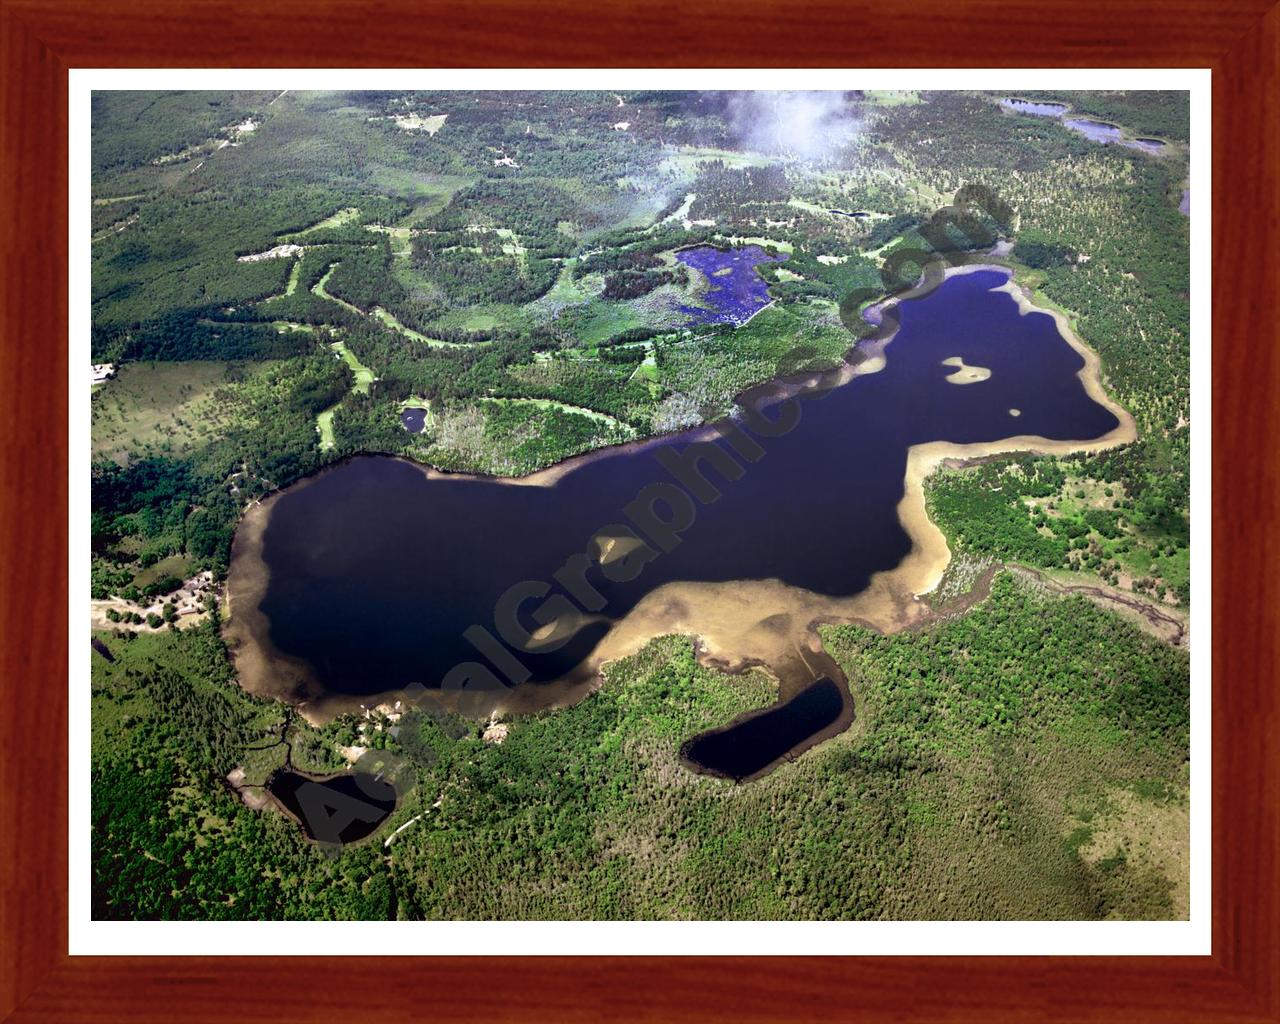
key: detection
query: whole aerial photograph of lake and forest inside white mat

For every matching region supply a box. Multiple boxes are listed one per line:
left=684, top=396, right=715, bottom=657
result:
left=87, top=85, right=1187, bottom=922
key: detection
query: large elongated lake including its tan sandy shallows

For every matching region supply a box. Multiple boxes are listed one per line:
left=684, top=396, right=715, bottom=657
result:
left=228, top=269, right=1119, bottom=778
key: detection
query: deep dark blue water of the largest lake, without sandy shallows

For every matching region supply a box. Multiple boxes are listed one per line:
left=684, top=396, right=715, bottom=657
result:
left=249, top=271, right=1116, bottom=716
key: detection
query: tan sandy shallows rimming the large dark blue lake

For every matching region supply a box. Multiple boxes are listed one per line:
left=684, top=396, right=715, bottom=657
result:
left=228, top=265, right=1137, bottom=721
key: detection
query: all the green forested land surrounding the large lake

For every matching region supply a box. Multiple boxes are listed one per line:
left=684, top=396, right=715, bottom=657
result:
left=92, top=85, right=1192, bottom=919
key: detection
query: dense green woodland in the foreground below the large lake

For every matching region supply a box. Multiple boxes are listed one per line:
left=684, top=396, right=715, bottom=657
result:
left=93, top=576, right=1188, bottom=919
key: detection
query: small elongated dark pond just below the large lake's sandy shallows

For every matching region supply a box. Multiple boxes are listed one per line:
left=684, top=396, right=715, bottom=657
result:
left=681, top=678, right=845, bottom=781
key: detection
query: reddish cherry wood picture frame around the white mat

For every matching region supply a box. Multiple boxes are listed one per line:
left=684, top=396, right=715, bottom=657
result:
left=0, top=0, right=1280, bottom=1024
